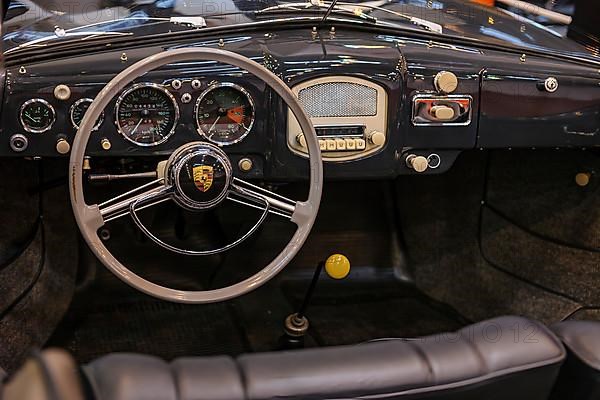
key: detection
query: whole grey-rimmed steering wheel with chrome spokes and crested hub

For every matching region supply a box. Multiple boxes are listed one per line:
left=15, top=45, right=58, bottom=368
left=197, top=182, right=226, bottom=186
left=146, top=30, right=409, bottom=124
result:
left=68, top=48, right=323, bottom=304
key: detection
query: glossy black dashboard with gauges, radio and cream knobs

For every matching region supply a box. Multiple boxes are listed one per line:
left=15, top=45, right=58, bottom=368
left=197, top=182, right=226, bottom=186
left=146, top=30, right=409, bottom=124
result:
left=0, top=29, right=600, bottom=179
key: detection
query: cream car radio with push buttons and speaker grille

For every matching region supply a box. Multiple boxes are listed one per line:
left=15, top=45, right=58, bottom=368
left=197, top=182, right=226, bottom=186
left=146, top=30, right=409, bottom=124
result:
left=287, top=76, right=387, bottom=161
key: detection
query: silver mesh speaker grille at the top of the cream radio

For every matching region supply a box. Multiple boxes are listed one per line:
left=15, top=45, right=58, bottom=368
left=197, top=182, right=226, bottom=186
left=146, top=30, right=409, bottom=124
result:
left=298, top=82, right=377, bottom=118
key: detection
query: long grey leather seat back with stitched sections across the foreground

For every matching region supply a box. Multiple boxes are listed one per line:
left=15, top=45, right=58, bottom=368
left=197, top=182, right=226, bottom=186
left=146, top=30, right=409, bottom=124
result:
left=4, top=317, right=566, bottom=400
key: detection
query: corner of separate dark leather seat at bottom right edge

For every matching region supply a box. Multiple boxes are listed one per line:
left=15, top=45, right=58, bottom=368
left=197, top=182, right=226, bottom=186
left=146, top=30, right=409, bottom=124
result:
left=552, top=321, right=600, bottom=400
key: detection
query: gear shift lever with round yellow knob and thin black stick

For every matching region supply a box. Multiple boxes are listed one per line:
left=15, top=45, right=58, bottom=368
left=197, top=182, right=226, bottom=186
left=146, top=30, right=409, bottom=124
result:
left=281, top=254, right=350, bottom=348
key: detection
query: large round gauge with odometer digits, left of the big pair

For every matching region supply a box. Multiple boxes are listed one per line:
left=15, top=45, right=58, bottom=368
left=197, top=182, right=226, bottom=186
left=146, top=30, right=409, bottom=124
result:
left=115, top=83, right=179, bottom=146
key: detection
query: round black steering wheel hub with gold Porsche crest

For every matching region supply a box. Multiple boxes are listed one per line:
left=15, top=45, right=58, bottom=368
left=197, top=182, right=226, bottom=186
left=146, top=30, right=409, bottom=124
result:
left=165, top=142, right=233, bottom=211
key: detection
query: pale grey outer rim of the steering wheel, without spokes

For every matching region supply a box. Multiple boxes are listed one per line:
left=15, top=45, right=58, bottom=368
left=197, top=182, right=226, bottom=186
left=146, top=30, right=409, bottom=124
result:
left=69, top=48, right=323, bottom=304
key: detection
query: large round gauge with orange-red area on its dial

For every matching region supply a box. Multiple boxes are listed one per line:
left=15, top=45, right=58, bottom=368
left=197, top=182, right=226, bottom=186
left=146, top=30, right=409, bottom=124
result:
left=195, top=83, right=254, bottom=146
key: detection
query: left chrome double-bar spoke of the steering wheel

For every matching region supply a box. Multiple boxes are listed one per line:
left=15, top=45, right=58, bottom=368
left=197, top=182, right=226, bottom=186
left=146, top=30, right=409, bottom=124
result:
left=98, top=178, right=173, bottom=223
